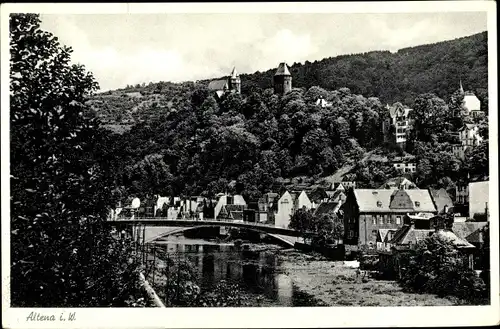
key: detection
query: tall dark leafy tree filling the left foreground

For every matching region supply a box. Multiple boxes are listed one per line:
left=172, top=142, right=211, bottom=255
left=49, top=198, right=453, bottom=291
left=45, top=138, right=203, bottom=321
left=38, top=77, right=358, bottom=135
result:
left=10, top=14, right=143, bottom=307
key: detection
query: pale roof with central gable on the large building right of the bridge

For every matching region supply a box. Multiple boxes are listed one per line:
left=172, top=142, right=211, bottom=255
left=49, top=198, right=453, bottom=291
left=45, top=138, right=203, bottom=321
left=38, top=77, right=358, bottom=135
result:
left=354, top=189, right=436, bottom=213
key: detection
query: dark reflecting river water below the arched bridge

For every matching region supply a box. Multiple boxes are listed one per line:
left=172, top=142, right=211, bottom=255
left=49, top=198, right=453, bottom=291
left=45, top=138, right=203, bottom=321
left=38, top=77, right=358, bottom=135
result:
left=151, top=235, right=318, bottom=306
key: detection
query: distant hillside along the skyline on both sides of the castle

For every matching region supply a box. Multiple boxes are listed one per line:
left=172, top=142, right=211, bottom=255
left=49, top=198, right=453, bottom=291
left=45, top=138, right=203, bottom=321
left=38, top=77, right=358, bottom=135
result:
left=90, top=32, right=488, bottom=128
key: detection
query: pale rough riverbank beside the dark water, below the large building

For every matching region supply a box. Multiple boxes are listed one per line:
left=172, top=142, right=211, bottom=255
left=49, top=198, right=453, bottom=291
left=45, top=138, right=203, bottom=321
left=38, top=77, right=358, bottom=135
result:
left=278, top=250, right=458, bottom=306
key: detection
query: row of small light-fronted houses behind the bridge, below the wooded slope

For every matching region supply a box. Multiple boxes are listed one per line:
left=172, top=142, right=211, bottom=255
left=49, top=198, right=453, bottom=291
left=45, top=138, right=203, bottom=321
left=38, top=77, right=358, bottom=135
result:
left=110, top=182, right=354, bottom=224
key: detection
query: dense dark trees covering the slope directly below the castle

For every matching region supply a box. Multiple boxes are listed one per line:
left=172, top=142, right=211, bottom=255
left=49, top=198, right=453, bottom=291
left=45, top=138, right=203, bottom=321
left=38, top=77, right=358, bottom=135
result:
left=100, top=87, right=385, bottom=197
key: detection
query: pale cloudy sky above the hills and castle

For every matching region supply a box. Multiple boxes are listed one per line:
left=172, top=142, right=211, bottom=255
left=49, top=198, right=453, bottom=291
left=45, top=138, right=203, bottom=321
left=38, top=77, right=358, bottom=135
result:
left=41, top=12, right=487, bottom=91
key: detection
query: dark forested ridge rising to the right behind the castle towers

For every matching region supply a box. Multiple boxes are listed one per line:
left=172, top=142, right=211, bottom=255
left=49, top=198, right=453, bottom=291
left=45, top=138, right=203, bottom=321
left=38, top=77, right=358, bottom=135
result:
left=241, top=32, right=488, bottom=105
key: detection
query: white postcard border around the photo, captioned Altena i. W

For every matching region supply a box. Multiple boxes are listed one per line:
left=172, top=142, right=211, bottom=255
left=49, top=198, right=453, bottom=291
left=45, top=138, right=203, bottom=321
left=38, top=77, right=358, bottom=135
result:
left=0, top=1, right=500, bottom=328
